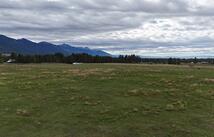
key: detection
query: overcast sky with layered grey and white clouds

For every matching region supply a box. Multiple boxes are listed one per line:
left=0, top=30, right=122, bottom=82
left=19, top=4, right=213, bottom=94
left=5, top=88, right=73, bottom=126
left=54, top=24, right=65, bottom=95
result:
left=0, top=0, right=214, bottom=57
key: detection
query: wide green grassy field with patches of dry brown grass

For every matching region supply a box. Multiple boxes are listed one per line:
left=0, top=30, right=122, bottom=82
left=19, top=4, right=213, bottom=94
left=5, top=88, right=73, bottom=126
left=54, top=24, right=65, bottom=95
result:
left=0, top=64, right=214, bottom=137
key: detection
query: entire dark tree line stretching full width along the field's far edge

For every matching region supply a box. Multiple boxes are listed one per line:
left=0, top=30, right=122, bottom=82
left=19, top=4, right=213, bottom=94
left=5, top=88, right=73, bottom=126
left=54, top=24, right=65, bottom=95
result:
left=0, top=53, right=214, bottom=65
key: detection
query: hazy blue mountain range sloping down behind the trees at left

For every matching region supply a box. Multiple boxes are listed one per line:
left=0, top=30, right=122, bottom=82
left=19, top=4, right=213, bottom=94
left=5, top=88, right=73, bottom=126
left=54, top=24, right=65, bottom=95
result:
left=0, top=35, right=111, bottom=56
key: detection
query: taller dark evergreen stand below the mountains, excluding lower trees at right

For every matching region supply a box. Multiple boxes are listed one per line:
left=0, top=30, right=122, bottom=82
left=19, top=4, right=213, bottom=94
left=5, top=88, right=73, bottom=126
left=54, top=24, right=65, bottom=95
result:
left=4, top=53, right=141, bottom=64
